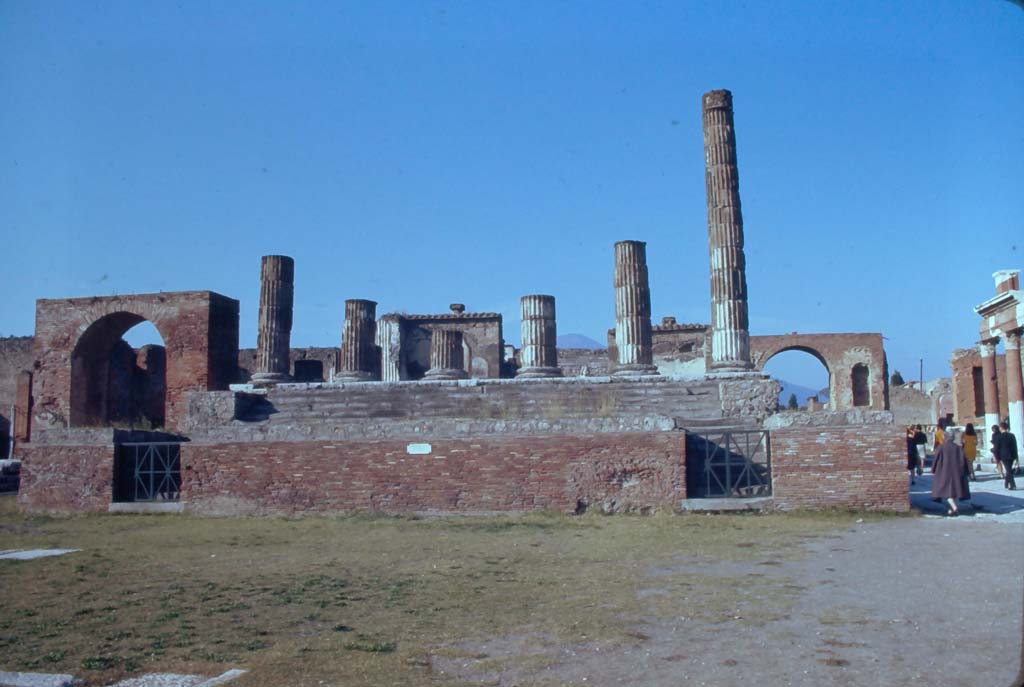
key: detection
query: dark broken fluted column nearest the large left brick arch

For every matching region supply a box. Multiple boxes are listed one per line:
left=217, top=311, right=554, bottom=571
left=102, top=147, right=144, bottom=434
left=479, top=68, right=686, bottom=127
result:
left=252, top=255, right=295, bottom=382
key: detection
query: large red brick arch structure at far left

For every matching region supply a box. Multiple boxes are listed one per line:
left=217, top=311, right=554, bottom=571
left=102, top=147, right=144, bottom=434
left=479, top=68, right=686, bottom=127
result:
left=34, top=291, right=239, bottom=430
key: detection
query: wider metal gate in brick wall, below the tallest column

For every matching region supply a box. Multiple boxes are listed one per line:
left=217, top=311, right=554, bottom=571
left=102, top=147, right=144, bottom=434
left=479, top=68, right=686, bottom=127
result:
left=686, top=430, right=771, bottom=499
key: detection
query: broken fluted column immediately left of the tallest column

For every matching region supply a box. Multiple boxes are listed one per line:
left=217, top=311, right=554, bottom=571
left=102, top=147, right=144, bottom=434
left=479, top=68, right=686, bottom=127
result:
left=614, top=241, right=657, bottom=377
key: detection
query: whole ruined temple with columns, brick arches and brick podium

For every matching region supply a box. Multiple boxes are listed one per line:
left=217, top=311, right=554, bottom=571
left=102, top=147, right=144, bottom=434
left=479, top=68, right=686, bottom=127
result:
left=11, top=90, right=908, bottom=514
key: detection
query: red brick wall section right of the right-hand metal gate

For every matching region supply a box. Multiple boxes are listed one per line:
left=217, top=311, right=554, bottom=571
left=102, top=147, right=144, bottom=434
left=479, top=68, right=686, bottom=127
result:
left=771, top=425, right=909, bottom=511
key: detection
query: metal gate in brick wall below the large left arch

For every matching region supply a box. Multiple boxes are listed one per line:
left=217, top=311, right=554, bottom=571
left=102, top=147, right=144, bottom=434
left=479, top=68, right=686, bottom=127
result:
left=114, top=442, right=181, bottom=502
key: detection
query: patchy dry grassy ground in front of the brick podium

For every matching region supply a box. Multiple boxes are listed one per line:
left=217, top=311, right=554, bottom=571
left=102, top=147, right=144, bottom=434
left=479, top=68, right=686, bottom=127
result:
left=0, top=499, right=897, bottom=687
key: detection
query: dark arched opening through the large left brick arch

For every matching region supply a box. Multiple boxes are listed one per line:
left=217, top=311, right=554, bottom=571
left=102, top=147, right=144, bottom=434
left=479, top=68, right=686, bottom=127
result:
left=71, top=312, right=167, bottom=429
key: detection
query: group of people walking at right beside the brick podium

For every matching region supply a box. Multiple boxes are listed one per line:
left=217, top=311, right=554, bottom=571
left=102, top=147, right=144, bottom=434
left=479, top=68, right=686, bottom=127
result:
left=906, top=422, right=1019, bottom=516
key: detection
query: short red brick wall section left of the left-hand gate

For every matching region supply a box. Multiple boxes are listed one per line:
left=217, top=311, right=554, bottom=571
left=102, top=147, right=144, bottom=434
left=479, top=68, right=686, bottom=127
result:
left=17, top=443, right=114, bottom=513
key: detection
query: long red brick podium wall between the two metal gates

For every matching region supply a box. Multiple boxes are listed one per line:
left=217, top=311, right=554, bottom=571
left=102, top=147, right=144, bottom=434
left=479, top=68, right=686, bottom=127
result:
left=181, top=432, right=685, bottom=514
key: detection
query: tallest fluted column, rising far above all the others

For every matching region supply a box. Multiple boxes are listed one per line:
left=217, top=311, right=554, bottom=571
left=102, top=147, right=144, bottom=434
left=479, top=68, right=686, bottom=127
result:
left=701, top=90, right=752, bottom=372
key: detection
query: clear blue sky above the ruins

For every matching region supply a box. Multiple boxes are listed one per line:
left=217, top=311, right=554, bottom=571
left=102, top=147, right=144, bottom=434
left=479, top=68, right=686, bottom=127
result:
left=0, top=0, right=1024, bottom=382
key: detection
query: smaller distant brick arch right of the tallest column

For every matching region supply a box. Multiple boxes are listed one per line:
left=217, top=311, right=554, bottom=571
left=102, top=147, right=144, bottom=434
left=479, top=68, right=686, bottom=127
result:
left=751, top=334, right=889, bottom=411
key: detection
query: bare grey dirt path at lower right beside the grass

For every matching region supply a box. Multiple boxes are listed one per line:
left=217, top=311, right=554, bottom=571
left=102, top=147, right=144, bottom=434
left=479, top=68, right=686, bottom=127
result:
left=433, top=517, right=1024, bottom=687
